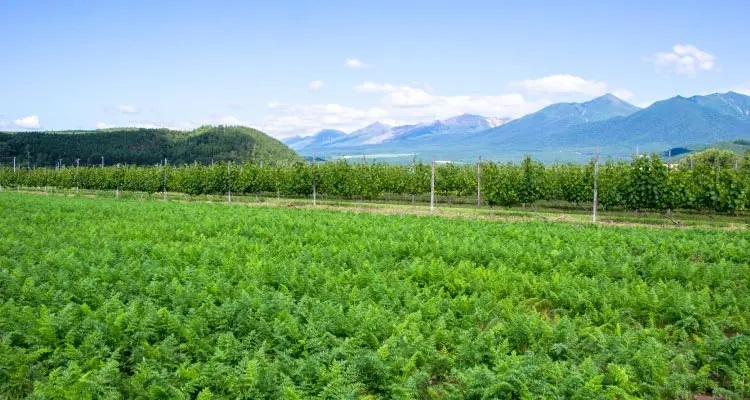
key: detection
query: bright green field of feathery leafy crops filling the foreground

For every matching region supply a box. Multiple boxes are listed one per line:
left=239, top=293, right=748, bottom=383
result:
left=0, top=192, right=750, bottom=399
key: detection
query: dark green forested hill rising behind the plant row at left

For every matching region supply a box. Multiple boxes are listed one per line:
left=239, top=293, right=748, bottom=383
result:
left=0, top=126, right=302, bottom=166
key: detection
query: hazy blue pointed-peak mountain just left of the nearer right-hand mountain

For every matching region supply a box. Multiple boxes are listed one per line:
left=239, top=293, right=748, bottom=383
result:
left=476, top=94, right=640, bottom=148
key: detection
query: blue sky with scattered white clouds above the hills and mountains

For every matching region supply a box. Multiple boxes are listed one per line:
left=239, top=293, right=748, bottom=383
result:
left=0, top=0, right=750, bottom=137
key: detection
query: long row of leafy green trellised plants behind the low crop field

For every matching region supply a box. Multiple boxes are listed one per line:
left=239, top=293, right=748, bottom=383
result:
left=0, top=151, right=750, bottom=213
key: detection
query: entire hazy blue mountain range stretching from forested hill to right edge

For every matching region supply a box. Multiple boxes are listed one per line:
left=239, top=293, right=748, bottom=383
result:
left=284, top=92, right=750, bottom=161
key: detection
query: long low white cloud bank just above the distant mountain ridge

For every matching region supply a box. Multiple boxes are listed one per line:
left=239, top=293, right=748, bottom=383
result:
left=261, top=82, right=549, bottom=137
